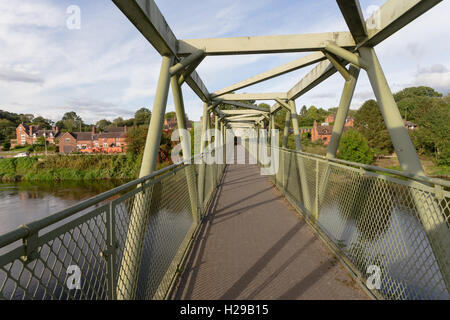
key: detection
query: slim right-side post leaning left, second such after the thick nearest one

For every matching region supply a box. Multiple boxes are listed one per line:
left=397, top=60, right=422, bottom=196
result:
left=289, top=100, right=314, bottom=216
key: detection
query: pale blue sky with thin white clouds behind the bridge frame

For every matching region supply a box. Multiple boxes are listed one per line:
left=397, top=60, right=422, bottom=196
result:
left=0, top=0, right=450, bottom=123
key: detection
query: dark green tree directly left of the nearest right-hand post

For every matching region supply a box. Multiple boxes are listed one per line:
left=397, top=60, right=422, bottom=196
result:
left=355, top=100, right=394, bottom=153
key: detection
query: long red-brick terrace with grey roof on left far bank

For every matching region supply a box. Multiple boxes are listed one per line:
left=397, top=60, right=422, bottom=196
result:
left=59, top=126, right=128, bottom=153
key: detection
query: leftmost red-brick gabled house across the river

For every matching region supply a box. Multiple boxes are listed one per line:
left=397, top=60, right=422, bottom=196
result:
left=11, top=123, right=61, bottom=147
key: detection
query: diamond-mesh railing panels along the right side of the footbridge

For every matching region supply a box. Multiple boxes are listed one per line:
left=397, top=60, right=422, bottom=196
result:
left=271, top=148, right=450, bottom=299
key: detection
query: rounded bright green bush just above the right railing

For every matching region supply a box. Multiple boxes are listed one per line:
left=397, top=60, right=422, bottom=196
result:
left=338, top=129, right=373, bottom=164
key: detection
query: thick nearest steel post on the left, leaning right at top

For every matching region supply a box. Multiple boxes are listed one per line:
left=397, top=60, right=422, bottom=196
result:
left=117, top=56, right=174, bottom=300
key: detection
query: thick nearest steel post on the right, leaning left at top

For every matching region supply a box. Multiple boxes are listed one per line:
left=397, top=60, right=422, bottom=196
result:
left=359, top=48, right=450, bottom=290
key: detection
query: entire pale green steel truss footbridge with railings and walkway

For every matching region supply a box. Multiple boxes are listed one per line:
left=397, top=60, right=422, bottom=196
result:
left=0, top=0, right=450, bottom=299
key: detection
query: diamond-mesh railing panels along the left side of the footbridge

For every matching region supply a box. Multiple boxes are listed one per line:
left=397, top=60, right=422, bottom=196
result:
left=0, top=154, right=224, bottom=300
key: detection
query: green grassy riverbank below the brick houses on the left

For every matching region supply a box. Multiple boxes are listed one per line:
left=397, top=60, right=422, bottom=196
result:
left=0, top=155, right=141, bottom=181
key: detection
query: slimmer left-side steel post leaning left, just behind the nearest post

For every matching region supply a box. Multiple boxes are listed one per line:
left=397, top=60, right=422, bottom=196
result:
left=170, top=75, right=199, bottom=225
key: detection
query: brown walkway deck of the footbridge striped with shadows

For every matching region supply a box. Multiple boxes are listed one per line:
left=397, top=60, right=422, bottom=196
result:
left=174, top=154, right=368, bottom=299
